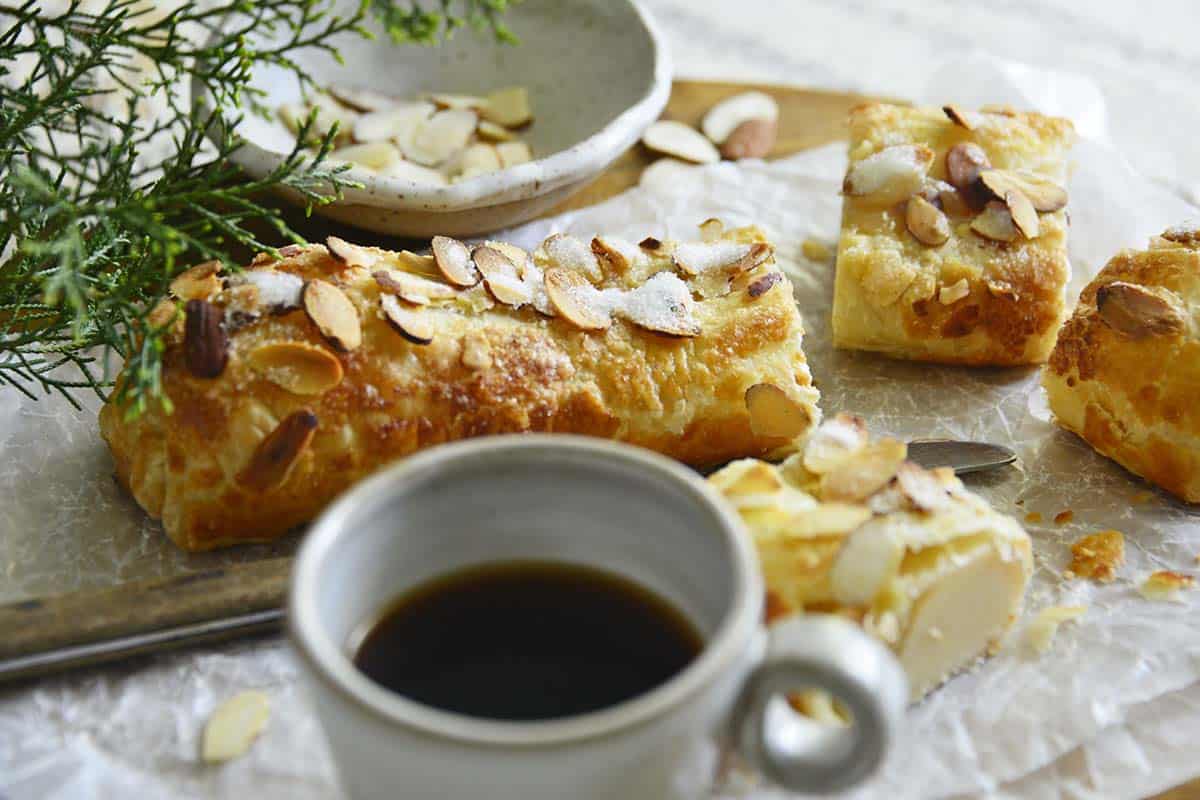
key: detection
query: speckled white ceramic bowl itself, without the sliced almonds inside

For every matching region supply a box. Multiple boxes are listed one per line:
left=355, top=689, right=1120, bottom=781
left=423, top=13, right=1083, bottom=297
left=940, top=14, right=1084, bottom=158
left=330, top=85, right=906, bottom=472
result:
left=211, top=0, right=671, bottom=236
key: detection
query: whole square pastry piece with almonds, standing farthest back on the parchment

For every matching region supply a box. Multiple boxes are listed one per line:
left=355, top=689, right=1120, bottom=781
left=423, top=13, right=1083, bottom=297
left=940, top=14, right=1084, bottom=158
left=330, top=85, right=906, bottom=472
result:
left=833, top=103, right=1074, bottom=365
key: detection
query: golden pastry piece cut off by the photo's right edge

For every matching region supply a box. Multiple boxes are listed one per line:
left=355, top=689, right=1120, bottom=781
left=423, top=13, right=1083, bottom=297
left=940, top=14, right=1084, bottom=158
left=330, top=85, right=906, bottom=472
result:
left=1042, top=224, right=1200, bottom=503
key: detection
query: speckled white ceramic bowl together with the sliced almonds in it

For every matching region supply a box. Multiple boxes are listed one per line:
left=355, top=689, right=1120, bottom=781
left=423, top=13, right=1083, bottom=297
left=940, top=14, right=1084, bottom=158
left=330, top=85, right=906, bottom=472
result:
left=210, top=0, right=671, bottom=236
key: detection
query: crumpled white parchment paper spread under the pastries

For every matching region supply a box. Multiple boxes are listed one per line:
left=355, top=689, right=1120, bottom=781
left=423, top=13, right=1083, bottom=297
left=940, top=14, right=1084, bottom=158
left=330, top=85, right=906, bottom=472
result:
left=0, top=60, right=1200, bottom=800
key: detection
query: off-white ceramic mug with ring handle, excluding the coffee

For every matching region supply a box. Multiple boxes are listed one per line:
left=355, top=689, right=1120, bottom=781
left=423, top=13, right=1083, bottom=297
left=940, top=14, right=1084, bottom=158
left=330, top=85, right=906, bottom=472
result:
left=288, top=435, right=908, bottom=800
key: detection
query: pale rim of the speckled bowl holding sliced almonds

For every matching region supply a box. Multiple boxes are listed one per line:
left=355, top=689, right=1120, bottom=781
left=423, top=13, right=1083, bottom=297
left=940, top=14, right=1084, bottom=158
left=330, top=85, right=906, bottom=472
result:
left=192, top=0, right=672, bottom=211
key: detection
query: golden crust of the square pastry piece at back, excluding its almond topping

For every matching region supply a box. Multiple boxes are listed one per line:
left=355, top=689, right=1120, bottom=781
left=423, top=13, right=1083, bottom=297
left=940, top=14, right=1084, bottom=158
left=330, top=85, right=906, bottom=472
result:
left=833, top=103, right=1074, bottom=366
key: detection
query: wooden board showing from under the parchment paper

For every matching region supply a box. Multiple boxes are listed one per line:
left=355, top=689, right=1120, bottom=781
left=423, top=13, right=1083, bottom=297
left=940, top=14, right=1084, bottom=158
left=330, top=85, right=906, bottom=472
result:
left=0, top=80, right=1200, bottom=800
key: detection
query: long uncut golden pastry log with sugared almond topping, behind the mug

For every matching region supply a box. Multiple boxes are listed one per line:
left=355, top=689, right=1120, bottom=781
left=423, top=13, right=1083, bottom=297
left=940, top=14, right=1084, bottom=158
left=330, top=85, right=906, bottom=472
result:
left=100, top=222, right=820, bottom=549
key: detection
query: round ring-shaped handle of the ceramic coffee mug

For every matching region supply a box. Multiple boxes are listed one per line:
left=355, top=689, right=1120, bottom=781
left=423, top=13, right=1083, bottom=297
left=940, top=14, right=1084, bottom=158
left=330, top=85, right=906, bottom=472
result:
left=731, top=614, right=908, bottom=793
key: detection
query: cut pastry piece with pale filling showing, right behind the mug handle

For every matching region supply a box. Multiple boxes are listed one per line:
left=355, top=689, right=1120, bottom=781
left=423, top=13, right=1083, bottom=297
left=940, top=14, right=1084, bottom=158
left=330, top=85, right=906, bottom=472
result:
left=709, top=415, right=1032, bottom=699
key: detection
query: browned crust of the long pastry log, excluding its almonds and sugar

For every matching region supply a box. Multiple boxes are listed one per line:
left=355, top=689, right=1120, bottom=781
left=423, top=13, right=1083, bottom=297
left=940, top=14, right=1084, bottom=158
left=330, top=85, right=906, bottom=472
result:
left=100, top=228, right=820, bottom=551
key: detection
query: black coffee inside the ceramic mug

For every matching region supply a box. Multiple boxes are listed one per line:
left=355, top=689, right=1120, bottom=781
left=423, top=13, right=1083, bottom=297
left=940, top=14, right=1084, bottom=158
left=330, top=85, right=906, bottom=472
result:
left=354, top=561, right=703, bottom=721
